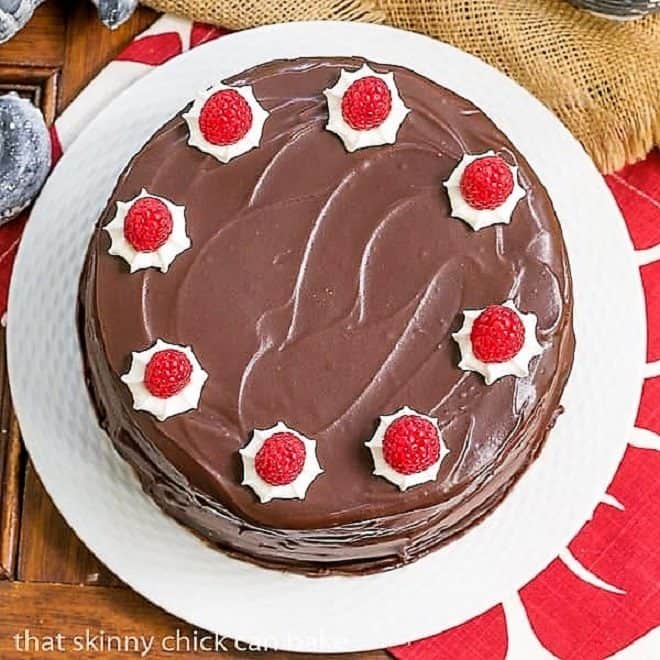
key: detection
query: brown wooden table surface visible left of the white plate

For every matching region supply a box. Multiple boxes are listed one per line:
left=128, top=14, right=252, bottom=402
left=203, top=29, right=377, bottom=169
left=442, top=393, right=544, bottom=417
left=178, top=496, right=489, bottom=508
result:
left=0, top=0, right=389, bottom=660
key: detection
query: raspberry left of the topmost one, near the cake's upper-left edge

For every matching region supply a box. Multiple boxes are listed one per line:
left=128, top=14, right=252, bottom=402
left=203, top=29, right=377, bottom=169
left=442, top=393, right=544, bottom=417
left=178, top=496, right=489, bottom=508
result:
left=199, top=89, right=252, bottom=145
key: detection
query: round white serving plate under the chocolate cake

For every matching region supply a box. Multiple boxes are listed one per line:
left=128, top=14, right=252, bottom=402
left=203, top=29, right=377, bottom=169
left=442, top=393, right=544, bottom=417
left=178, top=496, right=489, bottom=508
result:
left=8, top=22, right=645, bottom=652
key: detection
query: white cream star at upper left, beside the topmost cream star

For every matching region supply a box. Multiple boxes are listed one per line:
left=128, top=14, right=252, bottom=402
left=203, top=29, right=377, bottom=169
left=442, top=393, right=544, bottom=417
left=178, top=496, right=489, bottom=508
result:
left=183, top=83, right=268, bottom=163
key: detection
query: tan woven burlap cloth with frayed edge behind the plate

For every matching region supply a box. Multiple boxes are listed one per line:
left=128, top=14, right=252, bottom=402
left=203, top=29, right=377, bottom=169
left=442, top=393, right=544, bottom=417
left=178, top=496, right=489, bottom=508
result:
left=143, top=0, right=660, bottom=172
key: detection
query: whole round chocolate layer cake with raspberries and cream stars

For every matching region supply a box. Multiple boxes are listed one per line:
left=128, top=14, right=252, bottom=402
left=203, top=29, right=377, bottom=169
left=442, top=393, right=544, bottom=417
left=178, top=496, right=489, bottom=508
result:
left=79, top=57, right=574, bottom=575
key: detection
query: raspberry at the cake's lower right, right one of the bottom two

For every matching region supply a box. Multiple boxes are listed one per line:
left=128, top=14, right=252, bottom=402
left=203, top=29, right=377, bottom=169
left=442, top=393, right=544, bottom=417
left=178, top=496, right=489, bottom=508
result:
left=383, top=415, right=440, bottom=474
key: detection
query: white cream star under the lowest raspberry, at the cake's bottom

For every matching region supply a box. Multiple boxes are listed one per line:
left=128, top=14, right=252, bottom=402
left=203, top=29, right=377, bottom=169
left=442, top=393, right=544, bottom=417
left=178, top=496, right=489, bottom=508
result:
left=238, top=422, right=323, bottom=504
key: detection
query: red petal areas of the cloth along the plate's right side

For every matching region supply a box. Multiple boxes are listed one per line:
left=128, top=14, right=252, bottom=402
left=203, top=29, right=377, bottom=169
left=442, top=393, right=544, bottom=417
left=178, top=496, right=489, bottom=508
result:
left=390, top=157, right=660, bottom=660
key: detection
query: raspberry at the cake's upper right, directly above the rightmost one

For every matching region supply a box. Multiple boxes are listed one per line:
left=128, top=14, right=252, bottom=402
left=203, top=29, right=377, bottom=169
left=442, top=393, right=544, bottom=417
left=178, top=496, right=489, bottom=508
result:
left=461, top=156, right=513, bottom=210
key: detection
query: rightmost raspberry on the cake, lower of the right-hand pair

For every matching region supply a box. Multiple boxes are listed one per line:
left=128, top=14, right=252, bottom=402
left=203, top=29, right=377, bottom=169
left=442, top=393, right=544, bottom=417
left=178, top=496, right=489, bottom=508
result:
left=470, top=305, right=525, bottom=362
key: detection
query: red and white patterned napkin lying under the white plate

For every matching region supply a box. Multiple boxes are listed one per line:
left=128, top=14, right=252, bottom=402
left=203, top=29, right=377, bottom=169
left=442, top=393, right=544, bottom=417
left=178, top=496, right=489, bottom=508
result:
left=0, top=16, right=660, bottom=660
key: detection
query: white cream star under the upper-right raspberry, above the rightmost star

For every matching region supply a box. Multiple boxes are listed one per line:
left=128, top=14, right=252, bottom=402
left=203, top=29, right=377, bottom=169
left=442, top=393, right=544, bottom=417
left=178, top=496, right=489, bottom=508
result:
left=444, top=151, right=525, bottom=231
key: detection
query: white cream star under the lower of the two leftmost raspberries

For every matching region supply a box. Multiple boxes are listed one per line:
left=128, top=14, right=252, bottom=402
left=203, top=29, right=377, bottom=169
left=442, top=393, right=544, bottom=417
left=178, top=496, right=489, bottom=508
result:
left=121, top=339, right=208, bottom=422
